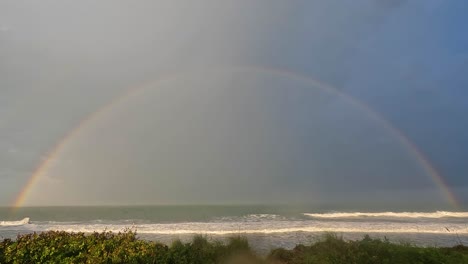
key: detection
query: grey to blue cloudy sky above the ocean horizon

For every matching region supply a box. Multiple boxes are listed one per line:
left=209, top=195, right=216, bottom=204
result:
left=0, top=0, right=468, bottom=206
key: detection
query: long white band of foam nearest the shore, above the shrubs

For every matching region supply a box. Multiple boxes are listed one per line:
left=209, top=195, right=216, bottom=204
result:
left=28, top=221, right=468, bottom=235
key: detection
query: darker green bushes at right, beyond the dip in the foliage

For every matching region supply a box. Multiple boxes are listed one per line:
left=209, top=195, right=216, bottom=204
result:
left=268, top=234, right=468, bottom=264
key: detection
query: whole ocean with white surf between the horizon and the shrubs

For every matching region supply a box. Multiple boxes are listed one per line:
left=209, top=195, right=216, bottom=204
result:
left=0, top=205, right=468, bottom=252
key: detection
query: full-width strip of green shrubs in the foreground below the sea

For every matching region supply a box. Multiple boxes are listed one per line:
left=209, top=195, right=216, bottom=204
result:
left=0, top=230, right=468, bottom=264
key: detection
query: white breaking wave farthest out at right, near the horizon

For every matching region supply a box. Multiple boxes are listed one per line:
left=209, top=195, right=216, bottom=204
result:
left=304, top=211, right=468, bottom=219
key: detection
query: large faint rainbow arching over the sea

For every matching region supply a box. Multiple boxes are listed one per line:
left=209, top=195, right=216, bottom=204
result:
left=12, top=66, right=459, bottom=210
